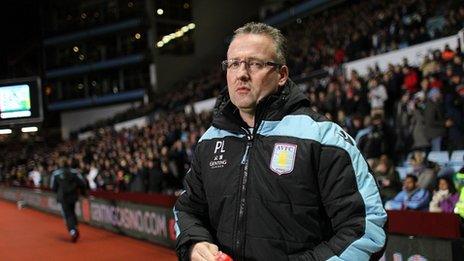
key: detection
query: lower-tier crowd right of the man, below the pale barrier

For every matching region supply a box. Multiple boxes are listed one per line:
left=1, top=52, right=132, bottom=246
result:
left=300, top=42, right=464, bottom=212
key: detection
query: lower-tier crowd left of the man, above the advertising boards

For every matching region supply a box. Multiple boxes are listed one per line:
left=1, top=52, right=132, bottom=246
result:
left=0, top=110, right=210, bottom=194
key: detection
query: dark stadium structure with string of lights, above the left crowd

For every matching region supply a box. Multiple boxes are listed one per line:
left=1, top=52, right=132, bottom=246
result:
left=2, top=0, right=261, bottom=138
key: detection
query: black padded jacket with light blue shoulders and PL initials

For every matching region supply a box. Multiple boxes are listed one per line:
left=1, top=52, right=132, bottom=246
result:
left=174, top=81, right=387, bottom=260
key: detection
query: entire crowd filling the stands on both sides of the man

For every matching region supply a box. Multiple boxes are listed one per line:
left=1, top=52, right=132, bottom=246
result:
left=0, top=0, right=464, bottom=212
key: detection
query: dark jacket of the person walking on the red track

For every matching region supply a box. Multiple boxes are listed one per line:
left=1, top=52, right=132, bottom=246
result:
left=52, top=168, right=87, bottom=203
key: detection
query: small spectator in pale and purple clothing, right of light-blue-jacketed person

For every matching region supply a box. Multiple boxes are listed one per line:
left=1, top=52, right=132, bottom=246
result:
left=429, top=177, right=459, bottom=213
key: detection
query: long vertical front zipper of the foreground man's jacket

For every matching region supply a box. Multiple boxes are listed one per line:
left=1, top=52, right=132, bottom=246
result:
left=234, top=128, right=253, bottom=260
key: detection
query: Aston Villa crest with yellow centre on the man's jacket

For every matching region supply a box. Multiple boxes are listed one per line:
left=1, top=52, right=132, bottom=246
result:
left=269, top=143, right=297, bottom=175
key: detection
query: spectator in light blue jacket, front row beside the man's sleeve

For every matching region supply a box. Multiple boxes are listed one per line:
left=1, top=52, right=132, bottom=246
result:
left=385, top=175, right=429, bottom=210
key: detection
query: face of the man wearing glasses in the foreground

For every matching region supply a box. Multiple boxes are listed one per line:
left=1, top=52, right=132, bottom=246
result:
left=227, top=34, right=288, bottom=113
